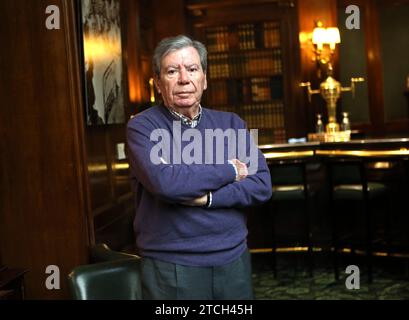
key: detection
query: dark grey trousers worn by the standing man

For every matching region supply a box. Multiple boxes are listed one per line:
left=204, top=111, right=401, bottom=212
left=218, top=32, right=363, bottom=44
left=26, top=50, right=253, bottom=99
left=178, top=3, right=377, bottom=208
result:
left=141, top=250, right=253, bottom=300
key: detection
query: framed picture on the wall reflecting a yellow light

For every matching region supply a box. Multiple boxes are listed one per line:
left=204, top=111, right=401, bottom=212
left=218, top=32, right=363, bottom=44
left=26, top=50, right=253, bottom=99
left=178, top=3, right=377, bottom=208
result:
left=78, top=0, right=125, bottom=125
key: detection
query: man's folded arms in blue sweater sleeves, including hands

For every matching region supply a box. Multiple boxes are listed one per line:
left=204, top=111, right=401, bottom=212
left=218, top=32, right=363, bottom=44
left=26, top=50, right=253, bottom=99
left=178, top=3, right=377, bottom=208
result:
left=127, top=117, right=272, bottom=209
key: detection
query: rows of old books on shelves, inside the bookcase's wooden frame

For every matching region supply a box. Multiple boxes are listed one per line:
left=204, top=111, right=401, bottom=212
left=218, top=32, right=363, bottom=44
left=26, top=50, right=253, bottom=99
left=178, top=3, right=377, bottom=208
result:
left=198, top=21, right=286, bottom=144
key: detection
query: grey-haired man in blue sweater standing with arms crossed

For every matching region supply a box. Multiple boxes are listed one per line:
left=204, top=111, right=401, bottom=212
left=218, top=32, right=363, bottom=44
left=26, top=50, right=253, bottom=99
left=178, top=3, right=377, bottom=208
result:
left=127, top=35, right=271, bottom=299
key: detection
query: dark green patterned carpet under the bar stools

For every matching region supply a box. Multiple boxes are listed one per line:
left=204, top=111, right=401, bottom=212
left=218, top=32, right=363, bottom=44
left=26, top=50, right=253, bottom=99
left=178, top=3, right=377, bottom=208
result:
left=252, top=253, right=409, bottom=300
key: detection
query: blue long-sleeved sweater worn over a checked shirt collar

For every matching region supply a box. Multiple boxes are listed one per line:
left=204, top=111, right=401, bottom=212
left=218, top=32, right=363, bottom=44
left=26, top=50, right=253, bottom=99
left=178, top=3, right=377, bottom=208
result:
left=127, top=106, right=272, bottom=266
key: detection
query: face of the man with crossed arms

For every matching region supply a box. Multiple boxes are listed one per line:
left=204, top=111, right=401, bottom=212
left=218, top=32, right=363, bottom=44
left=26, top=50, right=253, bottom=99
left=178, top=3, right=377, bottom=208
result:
left=155, top=47, right=207, bottom=111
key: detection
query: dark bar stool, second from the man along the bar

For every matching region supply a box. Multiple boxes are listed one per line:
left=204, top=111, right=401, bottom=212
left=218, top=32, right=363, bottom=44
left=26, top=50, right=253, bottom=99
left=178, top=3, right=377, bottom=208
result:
left=327, top=157, right=390, bottom=283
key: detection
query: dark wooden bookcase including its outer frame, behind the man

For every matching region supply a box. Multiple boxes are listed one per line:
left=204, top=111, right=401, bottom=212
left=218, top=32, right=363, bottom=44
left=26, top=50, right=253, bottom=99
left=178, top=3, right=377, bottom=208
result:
left=186, top=0, right=305, bottom=144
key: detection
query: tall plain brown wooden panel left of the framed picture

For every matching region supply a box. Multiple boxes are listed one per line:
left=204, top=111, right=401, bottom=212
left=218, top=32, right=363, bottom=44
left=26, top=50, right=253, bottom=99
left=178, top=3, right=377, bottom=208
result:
left=0, top=0, right=89, bottom=298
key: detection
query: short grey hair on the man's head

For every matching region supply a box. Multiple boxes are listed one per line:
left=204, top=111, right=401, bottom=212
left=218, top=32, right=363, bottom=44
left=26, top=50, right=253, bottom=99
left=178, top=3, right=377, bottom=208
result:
left=152, top=35, right=207, bottom=77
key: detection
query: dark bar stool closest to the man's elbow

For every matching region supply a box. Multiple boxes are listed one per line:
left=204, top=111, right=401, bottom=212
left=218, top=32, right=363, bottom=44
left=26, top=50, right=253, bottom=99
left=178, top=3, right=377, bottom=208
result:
left=269, top=159, right=313, bottom=277
